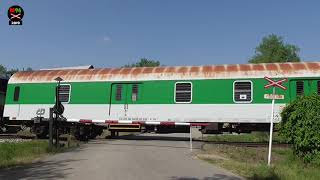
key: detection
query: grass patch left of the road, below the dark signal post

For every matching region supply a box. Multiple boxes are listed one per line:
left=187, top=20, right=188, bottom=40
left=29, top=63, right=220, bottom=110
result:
left=0, top=140, right=79, bottom=168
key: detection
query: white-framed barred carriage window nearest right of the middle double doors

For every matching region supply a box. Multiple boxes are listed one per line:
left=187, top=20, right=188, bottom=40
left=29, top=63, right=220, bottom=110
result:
left=175, top=83, right=192, bottom=103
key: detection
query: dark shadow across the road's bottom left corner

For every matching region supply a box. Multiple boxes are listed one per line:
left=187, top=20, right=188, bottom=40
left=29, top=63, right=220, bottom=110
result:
left=0, top=159, right=82, bottom=180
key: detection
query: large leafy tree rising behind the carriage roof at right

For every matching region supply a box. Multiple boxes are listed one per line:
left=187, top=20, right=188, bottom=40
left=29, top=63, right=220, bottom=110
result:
left=249, top=34, right=300, bottom=63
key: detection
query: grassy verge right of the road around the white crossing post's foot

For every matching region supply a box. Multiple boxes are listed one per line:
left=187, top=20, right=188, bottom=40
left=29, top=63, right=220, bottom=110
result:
left=198, top=144, right=320, bottom=180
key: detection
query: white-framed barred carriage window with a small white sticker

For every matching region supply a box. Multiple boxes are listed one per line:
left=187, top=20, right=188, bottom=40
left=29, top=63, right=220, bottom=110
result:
left=233, top=81, right=252, bottom=103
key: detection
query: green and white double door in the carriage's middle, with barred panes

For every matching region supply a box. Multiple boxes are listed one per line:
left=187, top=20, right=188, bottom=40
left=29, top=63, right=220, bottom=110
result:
left=110, top=83, right=138, bottom=117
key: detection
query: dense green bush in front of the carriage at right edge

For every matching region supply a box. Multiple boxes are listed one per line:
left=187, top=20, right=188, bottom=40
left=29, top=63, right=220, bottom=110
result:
left=279, top=94, right=320, bottom=162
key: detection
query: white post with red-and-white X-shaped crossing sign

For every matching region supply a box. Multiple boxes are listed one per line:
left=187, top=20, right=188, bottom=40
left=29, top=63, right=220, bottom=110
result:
left=264, top=77, right=288, bottom=166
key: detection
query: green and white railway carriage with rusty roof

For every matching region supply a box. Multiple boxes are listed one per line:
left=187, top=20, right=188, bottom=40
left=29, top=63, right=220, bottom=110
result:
left=4, top=62, right=320, bottom=134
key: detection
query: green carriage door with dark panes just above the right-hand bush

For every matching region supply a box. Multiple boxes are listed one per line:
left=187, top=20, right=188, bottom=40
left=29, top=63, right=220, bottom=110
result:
left=290, top=79, right=320, bottom=101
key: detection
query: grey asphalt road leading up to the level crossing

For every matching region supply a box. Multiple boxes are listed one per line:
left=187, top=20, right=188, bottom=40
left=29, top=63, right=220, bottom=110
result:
left=0, top=134, right=240, bottom=180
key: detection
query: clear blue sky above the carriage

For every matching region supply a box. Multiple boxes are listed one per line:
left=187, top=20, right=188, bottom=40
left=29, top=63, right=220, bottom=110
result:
left=0, top=0, right=320, bottom=69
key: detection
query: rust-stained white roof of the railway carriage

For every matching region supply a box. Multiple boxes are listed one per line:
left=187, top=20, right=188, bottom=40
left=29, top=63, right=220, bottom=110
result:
left=9, top=62, right=320, bottom=83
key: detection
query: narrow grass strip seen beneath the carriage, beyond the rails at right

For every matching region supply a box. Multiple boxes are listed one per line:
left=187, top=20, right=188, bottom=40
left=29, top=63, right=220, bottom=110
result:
left=205, top=132, right=285, bottom=143
